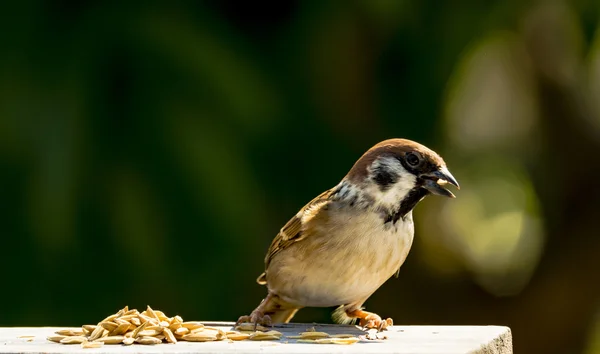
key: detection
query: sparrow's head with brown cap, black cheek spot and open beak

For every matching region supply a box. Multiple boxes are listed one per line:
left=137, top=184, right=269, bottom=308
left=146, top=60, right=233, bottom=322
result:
left=344, top=139, right=460, bottom=217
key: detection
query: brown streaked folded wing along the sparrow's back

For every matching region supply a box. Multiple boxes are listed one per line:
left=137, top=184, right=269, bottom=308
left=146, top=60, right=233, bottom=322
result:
left=256, top=189, right=333, bottom=284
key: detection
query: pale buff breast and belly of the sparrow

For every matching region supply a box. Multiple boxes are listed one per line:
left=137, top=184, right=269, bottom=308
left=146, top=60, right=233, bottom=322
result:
left=267, top=212, right=413, bottom=307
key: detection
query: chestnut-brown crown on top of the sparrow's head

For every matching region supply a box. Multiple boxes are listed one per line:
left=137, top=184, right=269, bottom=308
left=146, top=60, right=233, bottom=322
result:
left=346, top=139, right=446, bottom=183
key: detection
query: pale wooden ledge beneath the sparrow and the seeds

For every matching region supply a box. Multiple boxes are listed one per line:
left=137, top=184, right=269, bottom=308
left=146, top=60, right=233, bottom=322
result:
left=0, top=322, right=512, bottom=354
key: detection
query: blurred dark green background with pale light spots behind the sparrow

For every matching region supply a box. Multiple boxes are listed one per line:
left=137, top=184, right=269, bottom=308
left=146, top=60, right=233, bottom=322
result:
left=0, top=0, right=600, bottom=354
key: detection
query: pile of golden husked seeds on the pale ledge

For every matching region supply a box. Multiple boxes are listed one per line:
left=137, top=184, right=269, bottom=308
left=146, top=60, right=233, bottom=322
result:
left=48, top=306, right=282, bottom=348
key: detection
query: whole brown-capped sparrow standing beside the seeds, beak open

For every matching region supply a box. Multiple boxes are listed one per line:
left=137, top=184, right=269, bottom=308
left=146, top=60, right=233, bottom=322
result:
left=237, top=139, right=460, bottom=330
